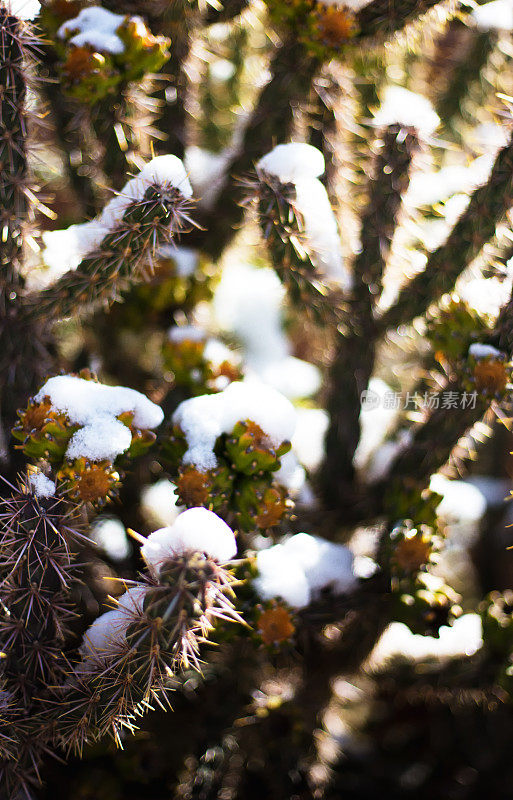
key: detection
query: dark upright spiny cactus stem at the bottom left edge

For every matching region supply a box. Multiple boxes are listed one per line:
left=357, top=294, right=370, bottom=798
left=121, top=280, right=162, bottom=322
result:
left=0, top=479, right=82, bottom=797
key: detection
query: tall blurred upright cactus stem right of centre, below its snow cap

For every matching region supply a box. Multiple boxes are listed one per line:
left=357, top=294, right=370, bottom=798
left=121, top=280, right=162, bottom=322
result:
left=323, top=120, right=419, bottom=505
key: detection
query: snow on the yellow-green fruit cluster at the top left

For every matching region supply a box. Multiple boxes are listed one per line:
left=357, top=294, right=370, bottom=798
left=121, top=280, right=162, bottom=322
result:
left=57, top=6, right=126, bottom=55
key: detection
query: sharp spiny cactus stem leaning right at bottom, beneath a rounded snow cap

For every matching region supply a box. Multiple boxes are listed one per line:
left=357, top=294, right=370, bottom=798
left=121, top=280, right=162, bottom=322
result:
left=54, top=551, right=242, bottom=752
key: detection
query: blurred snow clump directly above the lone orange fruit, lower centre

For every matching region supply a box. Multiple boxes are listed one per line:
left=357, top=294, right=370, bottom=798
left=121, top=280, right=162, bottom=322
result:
left=253, top=533, right=358, bottom=608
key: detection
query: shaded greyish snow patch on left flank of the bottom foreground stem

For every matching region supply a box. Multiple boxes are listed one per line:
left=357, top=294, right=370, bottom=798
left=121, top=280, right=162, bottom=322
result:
left=80, top=584, right=147, bottom=662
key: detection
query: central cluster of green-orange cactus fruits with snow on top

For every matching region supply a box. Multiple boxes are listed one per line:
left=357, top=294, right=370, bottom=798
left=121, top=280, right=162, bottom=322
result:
left=163, top=382, right=295, bottom=531
